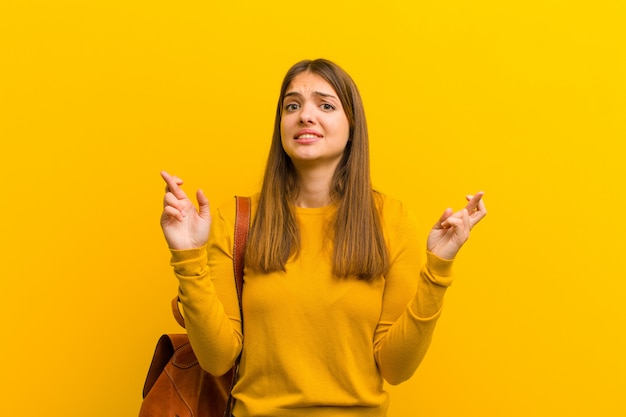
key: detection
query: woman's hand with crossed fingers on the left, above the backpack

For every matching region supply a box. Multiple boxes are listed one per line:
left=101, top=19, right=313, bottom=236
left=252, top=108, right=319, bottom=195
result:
left=161, top=171, right=211, bottom=250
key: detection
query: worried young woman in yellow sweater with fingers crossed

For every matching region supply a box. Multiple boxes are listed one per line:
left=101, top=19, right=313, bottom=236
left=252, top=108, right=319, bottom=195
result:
left=161, top=59, right=486, bottom=417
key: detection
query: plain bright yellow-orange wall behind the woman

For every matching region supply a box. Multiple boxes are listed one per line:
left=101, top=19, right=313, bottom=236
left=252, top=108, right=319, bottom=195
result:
left=0, top=0, right=626, bottom=417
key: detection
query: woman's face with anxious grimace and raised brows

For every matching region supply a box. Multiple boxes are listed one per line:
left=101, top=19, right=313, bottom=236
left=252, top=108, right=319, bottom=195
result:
left=280, top=72, right=350, bottom=170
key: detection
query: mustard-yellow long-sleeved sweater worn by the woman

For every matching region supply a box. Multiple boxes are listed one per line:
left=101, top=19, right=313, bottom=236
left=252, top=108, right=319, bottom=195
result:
left=172, top=196, right=452, bottom=417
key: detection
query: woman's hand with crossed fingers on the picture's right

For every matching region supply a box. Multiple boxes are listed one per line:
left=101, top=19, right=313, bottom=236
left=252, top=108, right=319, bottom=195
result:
left=426, top=191, right=487, bottom=259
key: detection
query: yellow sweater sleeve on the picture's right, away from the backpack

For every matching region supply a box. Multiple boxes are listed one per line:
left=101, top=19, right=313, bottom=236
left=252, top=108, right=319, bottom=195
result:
left=374, top=205, right=452, bottom=385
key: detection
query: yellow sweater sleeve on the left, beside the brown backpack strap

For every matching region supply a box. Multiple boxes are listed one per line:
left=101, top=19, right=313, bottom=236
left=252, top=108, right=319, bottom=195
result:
left=171, top=203, right=243, bottom=375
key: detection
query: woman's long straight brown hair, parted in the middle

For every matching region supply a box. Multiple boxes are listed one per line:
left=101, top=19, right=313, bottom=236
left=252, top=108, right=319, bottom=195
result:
left=246, top=59, right=389, bottom=280
